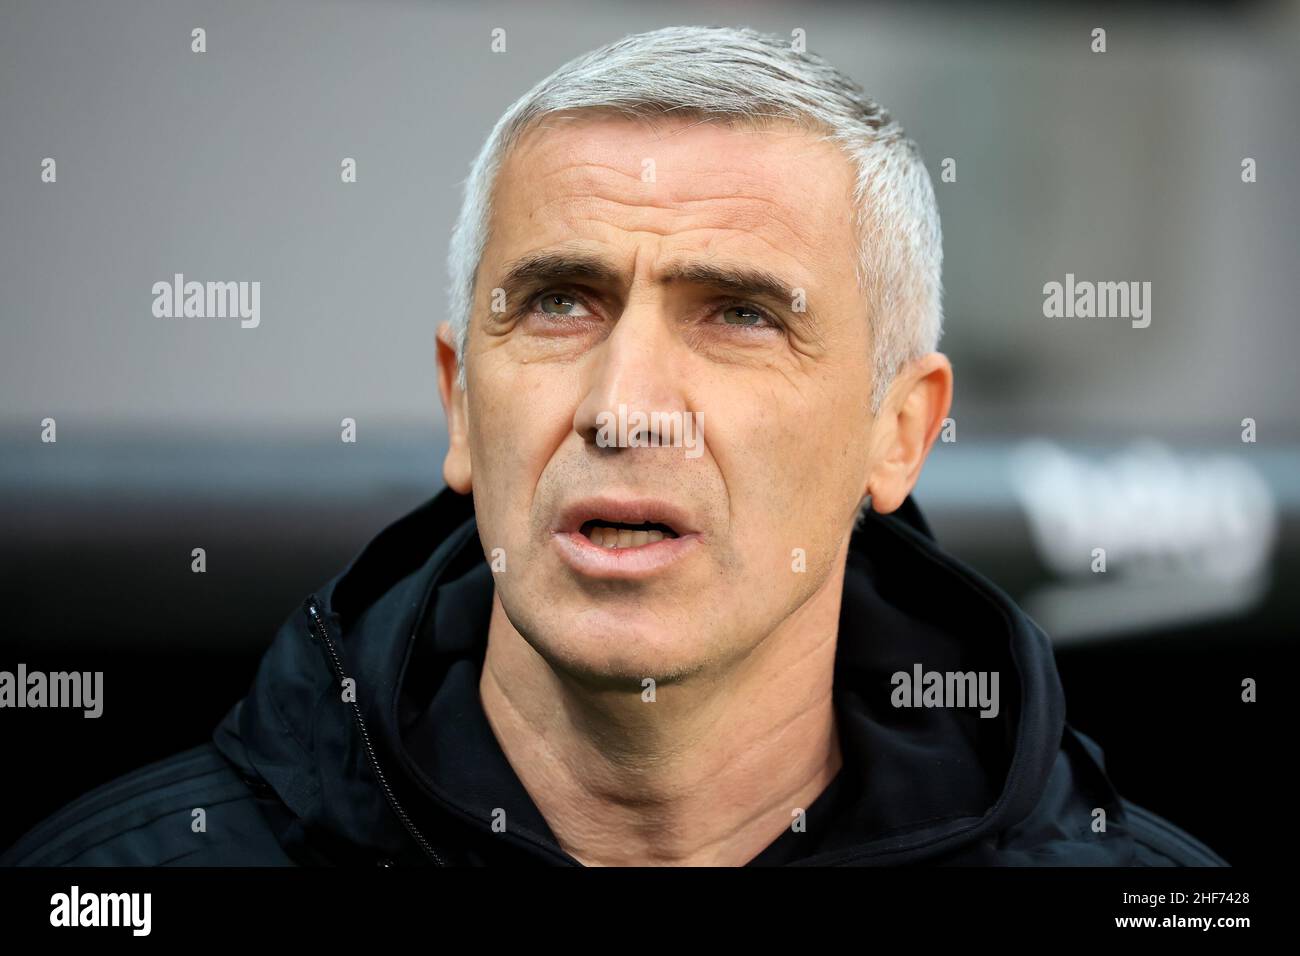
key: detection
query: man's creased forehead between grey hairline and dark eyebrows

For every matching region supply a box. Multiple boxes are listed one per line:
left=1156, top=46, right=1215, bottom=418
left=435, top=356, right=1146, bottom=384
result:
left=489, top=112, right=857, bottom=280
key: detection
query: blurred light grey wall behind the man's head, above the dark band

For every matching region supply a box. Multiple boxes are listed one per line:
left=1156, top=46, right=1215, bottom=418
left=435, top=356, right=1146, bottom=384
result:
left=0, top=0, right=1300, bottom=442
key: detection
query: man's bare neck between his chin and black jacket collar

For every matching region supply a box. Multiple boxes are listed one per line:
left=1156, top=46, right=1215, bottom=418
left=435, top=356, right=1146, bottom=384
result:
left=480, top=555, right=844, bottom=866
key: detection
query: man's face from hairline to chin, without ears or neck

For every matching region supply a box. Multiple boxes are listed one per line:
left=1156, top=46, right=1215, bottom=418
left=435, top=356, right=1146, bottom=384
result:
left=451, top=114, right=872, bottom=687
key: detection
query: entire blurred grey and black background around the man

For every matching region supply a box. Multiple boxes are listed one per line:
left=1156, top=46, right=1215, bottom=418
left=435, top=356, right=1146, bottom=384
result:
left=0, top=0, right=1300, bottom=864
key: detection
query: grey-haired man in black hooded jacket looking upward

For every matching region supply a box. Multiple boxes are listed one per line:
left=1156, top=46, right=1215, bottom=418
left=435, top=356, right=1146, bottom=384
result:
left=5, top=29, right=1223, bottom=865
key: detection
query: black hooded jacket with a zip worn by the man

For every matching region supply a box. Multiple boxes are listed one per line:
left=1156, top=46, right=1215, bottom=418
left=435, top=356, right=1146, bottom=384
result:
left=0, top=490, right=1225, bottom=866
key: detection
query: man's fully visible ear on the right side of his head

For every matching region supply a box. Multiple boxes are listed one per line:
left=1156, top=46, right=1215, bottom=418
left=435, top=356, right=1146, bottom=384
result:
left=866, top=352, right=953, bottom=515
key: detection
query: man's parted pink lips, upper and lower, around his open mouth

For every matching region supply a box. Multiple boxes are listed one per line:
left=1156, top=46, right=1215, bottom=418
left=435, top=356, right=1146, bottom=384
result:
left=551, top=497, right=701, bottom=580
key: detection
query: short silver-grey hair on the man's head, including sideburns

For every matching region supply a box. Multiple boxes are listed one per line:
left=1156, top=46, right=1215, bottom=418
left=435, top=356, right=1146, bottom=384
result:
left=447, top=26, right=943, bottom=412
